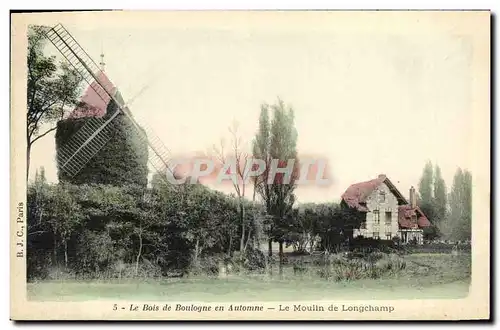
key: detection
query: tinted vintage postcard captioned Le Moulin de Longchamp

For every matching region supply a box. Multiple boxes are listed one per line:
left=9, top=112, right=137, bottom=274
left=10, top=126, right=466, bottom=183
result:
left=10, top=10, right=491, bottom=320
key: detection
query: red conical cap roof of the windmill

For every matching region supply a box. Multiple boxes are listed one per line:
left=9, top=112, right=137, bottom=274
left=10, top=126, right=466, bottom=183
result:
left=69, top=71, right=116, bottom=118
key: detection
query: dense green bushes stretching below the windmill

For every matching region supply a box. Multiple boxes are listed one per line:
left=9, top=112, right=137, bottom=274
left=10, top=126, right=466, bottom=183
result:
left=28, top=171, right=255, bottom=279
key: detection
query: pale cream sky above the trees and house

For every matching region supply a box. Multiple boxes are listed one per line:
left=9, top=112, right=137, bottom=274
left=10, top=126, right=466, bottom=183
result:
left=26, top=14, right=474, bottom=202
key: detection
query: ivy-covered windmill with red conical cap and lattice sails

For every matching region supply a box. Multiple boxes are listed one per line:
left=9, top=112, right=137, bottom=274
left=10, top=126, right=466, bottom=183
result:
left=46, top=24, right=173, bottom=185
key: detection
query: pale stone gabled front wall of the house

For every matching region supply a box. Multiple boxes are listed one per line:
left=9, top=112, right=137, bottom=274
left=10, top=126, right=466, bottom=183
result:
left=354, top=183, right=399, bottom=239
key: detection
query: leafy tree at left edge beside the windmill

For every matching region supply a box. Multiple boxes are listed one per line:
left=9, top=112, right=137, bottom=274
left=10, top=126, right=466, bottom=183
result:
left=26, top=26, right=82, bottom=180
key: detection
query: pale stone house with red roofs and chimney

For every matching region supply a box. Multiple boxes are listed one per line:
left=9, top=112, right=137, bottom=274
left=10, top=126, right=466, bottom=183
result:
left=341, top=174, right=432, bottom=244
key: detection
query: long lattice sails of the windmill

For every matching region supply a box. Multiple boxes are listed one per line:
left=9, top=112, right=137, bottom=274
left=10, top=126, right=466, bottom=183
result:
left=45, top=24, right=173, bottom=186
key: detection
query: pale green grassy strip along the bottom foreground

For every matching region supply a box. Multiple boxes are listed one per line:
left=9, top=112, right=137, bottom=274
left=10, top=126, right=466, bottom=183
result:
left=28, top=254, right=470, bottom=302
